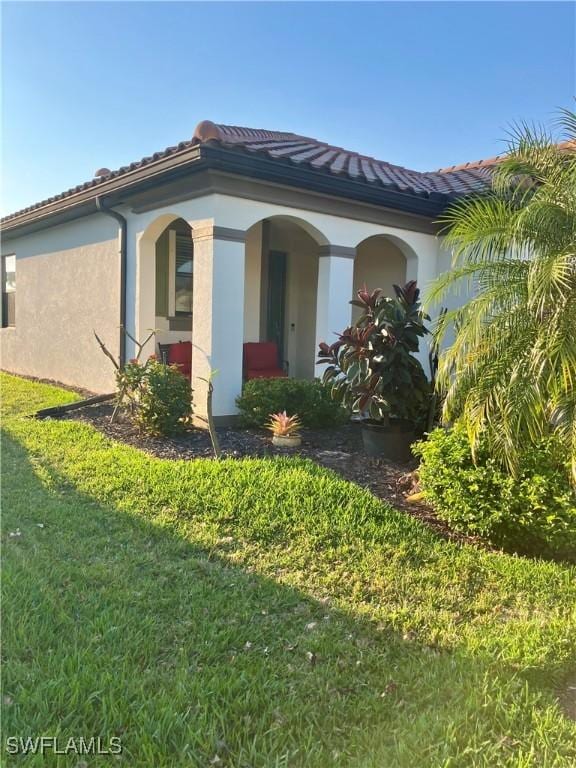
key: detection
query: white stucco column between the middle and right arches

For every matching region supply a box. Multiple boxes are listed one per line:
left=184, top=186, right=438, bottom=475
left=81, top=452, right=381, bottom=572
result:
left=315, top=245, right=356, bottom=377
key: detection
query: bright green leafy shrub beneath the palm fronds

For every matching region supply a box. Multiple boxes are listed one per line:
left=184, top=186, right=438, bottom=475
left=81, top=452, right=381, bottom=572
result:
left=413, top=425, right=576, bottom=560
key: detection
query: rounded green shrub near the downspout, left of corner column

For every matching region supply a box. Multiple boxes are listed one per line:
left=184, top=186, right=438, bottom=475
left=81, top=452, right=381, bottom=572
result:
left=116, top=357, right=192, bottom=435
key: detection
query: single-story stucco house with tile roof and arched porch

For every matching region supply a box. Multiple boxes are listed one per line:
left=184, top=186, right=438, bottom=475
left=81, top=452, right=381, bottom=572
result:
left=0, top=120, right=494, bottom=418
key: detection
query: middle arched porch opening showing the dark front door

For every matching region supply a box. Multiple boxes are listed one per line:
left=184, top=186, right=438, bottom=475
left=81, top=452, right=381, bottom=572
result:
left=244, top=216, right=327, bottom=378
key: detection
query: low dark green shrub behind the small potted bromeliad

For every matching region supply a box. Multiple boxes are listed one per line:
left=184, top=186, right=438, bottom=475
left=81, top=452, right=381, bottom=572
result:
left=236, top=379, right=348, bottom=427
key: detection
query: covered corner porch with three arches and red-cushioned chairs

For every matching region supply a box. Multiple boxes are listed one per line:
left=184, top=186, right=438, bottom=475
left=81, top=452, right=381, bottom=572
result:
left=135, top=207, right=434, bottom=420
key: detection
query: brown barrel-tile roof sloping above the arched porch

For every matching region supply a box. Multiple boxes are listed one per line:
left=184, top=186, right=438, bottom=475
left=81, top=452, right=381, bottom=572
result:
left=2, top=120, right=497, bottom=223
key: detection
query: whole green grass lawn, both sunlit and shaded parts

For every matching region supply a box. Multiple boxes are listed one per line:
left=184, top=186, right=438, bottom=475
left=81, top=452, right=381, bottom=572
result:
left=1, top=375, right=576, bottom=768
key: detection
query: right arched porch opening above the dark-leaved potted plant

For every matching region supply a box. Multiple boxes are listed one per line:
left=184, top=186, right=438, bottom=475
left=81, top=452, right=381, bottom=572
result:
left=352, top=235, right=412, bottom=319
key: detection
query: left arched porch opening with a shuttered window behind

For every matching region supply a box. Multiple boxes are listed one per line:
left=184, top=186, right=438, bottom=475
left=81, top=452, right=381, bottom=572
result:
left=137, top=214, right=194, bottom=354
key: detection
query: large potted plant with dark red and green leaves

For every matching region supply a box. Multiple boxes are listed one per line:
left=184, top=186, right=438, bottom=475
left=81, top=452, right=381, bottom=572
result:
left=318, top=280, right=431, bottom=462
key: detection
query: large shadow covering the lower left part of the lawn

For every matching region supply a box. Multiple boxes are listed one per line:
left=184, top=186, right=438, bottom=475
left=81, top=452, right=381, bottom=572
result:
left=3, top=436, right=569, bottom=768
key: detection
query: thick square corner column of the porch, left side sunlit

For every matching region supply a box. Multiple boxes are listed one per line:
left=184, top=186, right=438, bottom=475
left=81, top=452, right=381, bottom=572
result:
left=192, top=225, right=245, bottom=418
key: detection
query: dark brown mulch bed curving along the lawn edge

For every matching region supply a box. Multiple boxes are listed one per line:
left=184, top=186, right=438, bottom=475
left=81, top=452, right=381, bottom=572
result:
left=66, top=403, right=484, bottom=546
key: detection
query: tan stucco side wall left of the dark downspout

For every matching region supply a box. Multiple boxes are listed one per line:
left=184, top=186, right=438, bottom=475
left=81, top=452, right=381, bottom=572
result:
left=0, top=216, right=120, bottom=392
